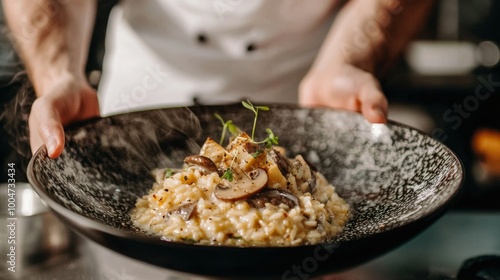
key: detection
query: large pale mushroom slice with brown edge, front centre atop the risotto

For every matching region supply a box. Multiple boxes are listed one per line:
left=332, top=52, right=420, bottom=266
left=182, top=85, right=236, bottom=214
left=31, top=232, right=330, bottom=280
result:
left=214, top=169, right=267, bottom=200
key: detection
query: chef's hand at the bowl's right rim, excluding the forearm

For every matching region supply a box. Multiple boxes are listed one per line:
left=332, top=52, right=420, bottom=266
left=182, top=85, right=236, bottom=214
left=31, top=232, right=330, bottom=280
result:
left=299, top=63, right=388, bottom=123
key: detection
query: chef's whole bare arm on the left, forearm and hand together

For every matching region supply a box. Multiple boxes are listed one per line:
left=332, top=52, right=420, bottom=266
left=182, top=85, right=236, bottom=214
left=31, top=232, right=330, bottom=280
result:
left=2, top=0, right=99, bottom=158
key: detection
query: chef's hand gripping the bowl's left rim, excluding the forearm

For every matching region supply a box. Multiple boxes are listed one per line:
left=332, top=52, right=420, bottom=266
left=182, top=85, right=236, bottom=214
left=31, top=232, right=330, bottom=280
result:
left=29, top=76, right=99, bottom=158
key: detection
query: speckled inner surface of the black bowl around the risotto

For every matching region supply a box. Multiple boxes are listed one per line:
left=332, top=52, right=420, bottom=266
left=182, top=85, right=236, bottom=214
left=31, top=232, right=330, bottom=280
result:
left=28, top=104, right=463, bottom=276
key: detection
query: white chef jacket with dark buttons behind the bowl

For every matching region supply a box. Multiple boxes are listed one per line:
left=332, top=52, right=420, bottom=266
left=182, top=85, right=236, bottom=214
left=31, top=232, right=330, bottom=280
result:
left=98, top=0, right=339, bottom=116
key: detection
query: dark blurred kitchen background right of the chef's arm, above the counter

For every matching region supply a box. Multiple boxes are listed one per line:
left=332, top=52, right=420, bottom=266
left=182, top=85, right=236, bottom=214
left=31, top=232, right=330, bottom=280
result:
left=383, top=0, right=500, bottom=209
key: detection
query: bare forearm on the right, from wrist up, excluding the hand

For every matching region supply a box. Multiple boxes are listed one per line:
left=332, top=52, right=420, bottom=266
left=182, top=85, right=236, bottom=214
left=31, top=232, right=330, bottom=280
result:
left=313, top=0, right=434, bottom=75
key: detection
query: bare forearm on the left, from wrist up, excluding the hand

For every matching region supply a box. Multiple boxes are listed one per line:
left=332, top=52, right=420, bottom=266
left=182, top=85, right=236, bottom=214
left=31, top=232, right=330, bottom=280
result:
left=3, top=0, right=96, bottom=96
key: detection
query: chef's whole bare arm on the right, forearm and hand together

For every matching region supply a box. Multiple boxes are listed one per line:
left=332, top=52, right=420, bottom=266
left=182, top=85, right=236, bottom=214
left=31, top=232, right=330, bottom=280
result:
left=299, top=0, right=434, bottom=123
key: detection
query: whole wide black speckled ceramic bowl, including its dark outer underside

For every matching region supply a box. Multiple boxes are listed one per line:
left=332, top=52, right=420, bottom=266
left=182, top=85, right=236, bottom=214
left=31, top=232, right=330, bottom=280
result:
left=28, top=104, right=463, bottom=279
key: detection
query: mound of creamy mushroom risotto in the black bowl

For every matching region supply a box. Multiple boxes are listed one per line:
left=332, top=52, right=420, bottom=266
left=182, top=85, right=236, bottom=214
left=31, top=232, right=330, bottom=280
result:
left=131, top=133, right=349, bottom=246
